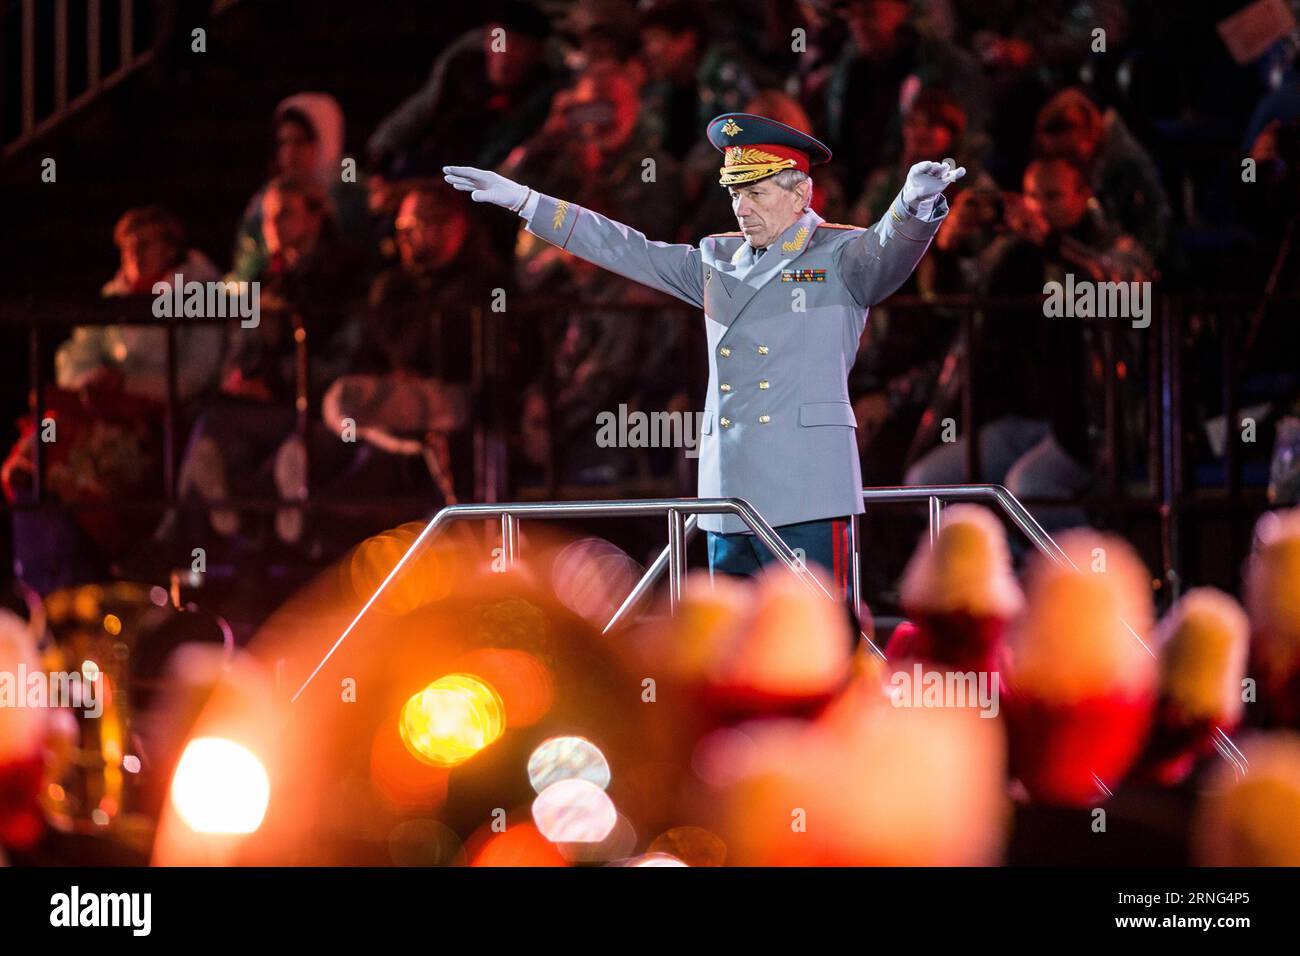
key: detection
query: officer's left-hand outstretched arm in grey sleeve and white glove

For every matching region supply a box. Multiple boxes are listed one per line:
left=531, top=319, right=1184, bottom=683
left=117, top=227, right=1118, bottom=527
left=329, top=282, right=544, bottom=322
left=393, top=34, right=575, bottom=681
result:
left=442, top=166, right=705, bottom=308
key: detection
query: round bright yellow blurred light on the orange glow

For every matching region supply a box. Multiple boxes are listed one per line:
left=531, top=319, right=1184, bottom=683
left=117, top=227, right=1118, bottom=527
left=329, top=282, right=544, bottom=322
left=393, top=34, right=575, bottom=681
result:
left=400, top=674, right=506, bottom=767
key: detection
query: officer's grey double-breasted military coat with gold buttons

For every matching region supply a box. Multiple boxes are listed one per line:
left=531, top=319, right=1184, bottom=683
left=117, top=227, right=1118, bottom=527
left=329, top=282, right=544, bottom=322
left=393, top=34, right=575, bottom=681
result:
left=528, top=195, right=948, bottom=533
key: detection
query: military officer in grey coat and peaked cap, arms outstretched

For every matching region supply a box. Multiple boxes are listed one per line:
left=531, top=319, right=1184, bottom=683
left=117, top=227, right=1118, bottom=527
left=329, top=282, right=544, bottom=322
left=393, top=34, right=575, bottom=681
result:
left=443, top=113, right=966, bottom=594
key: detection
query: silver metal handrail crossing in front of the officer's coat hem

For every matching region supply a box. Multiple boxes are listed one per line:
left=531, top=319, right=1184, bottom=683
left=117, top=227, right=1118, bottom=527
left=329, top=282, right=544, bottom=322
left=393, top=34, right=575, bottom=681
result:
left=291, top=498, right=847, bottom=701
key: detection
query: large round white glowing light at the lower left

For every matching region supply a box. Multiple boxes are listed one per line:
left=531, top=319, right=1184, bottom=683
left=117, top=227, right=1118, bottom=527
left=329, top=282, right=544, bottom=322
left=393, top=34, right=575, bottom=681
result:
left=172, top=737, right=270, bottom=834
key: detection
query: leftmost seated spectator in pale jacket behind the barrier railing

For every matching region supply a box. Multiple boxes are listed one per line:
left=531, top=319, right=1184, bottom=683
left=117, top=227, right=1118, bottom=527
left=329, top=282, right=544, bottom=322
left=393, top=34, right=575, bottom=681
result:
left=3, top=206, right=225, bottom=591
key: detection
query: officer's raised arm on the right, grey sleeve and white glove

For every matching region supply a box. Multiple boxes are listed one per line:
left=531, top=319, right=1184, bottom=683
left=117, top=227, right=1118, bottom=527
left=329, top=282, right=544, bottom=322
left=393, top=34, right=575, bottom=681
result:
left=839, top=163, right=966, bottom=307
